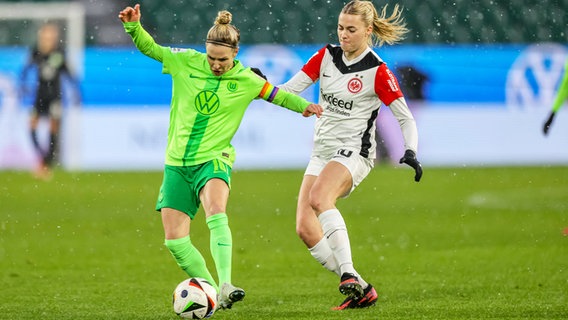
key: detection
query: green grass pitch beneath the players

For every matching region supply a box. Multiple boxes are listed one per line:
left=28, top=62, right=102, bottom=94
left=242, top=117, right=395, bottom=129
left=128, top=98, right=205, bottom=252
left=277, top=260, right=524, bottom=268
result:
left=0, top=166, right=568, bottom=320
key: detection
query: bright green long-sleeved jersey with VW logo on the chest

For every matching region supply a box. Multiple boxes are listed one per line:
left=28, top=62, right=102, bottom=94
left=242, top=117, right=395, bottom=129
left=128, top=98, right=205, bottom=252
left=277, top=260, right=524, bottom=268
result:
left=124, top=22, right=310, bottom=166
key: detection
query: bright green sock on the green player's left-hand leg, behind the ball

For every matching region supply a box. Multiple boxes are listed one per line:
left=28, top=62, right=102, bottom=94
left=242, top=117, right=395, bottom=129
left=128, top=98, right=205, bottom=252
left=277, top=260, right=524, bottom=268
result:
left=165, top=236, right=218, bottom=289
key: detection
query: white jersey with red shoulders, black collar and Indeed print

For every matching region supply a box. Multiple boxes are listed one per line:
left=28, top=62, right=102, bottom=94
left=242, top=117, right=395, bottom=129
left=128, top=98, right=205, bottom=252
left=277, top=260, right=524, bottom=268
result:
left=279, top=45, right=418, bottom=159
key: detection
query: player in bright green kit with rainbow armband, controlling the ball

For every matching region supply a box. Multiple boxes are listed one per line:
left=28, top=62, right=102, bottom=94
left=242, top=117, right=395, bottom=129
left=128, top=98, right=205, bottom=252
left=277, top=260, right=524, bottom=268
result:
left=118, top=4, right=323, bottom=308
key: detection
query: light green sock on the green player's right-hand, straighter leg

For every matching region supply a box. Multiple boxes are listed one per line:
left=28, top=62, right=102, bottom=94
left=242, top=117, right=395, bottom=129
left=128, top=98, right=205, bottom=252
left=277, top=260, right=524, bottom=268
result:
left=205, top=213, right=233, bottom=285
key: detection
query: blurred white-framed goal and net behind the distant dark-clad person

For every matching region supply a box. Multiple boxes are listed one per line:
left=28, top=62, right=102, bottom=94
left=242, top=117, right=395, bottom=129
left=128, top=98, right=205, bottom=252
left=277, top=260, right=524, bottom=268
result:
left=0, top=2, right=85, bottom=170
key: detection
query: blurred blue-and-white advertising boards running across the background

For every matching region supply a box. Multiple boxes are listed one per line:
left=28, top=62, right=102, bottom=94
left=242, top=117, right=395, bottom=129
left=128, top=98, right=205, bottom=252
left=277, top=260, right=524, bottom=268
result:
left=0, top=43, right=568, bottom=170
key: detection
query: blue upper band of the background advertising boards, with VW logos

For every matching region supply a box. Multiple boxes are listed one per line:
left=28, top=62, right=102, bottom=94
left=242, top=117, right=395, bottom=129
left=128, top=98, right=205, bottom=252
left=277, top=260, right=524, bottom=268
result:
left=0, top=44, right=568, bottom=107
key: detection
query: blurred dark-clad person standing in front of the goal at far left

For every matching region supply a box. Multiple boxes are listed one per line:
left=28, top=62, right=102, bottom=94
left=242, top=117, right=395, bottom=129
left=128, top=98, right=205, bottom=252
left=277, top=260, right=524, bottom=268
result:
left=20, top=22, right=81, bottom=179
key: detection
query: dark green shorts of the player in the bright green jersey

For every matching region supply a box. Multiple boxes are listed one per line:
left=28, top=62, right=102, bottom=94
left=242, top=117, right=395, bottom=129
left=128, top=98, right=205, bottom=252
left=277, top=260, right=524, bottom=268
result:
left=156, top=159, right=231, bottom=220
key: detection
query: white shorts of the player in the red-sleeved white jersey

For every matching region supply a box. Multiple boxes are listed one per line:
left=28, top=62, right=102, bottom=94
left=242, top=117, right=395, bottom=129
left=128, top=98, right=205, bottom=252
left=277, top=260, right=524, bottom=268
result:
left=304, top=149, right=374, bottom=197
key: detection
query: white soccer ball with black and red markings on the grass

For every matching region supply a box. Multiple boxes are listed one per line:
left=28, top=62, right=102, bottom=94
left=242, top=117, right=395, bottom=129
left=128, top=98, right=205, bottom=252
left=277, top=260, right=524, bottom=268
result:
left=173, top=278, right=217, bottom=319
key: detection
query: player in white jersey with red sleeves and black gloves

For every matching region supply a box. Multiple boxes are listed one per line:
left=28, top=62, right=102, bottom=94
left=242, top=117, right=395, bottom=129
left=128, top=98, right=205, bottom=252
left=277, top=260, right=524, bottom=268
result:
left=280, top=1, right=422, bottom=310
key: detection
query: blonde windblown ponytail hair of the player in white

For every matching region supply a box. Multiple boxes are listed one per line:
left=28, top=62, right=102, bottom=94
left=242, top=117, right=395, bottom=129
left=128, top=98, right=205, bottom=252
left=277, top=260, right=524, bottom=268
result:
left=341, top=0, right=408, bottom=47
